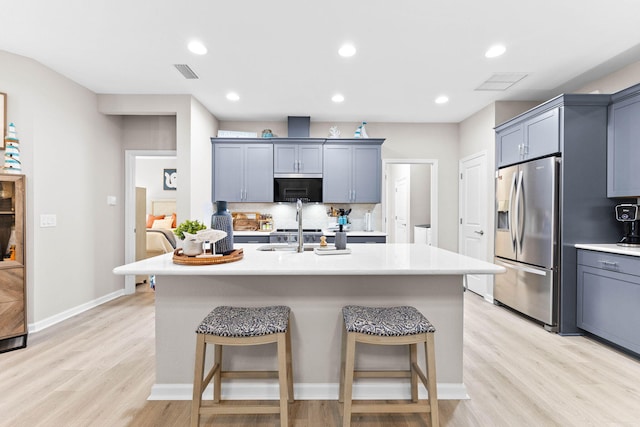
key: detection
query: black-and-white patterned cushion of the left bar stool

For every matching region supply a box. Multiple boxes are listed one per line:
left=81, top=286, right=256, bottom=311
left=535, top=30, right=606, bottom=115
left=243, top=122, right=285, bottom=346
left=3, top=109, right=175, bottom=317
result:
left=196, top=305, right=291, bottom=337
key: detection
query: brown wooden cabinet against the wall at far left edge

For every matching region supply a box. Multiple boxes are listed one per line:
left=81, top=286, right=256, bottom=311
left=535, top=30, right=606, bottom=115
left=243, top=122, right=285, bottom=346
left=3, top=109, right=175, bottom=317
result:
left=0, top=174, right=27, bottom=353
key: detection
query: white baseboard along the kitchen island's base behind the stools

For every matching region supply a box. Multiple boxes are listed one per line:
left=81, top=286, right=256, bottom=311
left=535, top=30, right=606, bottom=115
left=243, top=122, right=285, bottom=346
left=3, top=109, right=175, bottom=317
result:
left=148, top=381, right=470, bottom=400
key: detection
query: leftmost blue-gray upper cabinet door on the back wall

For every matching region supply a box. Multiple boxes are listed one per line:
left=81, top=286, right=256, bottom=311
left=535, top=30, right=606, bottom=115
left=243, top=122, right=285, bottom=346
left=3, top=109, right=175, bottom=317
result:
left=213, top=144, right=246, bottom=202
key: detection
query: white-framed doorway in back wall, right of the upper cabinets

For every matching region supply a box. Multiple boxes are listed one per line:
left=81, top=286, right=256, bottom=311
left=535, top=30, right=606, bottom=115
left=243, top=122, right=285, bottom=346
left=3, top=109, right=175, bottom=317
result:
left=382, top=159, right=438, bottom=246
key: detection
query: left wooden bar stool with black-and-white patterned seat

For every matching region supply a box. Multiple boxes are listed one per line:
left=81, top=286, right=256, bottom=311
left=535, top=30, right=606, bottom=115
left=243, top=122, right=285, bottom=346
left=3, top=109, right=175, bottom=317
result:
left=191, top=306, right=293, bottom=427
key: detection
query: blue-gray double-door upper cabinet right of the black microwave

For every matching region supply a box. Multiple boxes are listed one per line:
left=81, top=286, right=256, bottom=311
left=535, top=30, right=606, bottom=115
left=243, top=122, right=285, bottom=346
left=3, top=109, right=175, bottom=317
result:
left=322, top=139, right=384, bottom=203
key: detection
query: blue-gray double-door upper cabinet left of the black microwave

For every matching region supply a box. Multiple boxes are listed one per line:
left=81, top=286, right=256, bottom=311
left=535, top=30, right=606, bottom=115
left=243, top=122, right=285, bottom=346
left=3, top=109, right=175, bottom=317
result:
left=212, top=138, right=273, bottom=202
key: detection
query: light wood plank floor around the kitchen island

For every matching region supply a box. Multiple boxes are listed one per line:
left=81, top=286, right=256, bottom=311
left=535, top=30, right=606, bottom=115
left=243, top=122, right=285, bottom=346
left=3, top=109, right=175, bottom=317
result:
left=0, top=288, right=640, bottom=427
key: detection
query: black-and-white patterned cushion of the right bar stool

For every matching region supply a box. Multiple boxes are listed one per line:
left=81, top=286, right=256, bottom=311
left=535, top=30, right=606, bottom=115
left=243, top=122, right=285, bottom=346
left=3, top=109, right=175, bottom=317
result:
left=342, top=305, right=436, bottom=336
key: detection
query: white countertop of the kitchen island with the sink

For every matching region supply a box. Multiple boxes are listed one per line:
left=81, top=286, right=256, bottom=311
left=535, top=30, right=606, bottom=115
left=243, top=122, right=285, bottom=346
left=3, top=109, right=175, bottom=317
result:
left=113, top=243, right=505, bottom=276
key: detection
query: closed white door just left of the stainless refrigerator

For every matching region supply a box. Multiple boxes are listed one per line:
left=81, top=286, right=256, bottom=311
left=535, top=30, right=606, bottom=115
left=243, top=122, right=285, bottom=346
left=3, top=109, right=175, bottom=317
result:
left=458, top=153, right=491, bottom=299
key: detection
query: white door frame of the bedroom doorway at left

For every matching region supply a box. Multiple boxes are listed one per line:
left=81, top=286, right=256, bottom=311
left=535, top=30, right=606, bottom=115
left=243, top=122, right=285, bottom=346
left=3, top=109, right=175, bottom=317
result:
left=124, top=150, right=179, bottom=295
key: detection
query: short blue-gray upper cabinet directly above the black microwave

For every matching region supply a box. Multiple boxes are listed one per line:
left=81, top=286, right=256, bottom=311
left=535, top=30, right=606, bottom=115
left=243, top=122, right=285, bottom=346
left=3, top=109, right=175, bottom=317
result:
left=273, top=140, right=324, bottom=178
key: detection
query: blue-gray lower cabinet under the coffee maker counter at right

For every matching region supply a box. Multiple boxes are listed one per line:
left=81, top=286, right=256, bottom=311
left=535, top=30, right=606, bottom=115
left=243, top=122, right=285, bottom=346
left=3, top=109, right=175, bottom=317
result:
left=577, top=249, right=640, bottom=354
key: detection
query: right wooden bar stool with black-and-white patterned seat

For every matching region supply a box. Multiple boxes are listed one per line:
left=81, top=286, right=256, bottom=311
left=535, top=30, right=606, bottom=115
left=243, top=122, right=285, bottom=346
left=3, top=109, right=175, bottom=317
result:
left=338, top=305, right=439, bottom=427
